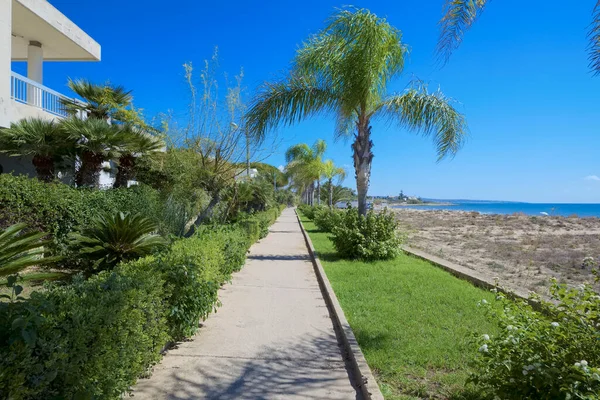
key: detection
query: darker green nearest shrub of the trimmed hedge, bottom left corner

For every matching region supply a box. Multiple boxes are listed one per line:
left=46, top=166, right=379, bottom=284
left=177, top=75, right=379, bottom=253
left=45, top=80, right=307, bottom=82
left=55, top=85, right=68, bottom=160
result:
left=0, top=265, right=167, bottom=399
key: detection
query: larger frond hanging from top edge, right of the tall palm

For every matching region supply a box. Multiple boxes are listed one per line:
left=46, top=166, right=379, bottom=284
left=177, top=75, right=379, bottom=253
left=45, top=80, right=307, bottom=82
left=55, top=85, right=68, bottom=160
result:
left=436, top=0, right=487, bottom=64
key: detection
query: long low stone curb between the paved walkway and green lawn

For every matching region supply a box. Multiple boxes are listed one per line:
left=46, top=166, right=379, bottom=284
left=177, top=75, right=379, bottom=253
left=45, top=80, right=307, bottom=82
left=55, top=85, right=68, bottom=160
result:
left=295, top=210, right=384, bottom=400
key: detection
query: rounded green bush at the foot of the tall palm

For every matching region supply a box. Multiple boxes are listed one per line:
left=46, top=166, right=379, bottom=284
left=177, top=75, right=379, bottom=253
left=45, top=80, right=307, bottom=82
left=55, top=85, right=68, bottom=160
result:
left=330, top=209, right=402, bottom=261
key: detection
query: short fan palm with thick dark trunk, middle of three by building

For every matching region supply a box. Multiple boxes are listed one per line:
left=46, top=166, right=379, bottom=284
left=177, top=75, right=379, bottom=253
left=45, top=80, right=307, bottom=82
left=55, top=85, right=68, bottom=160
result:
left=61, top=118, right=126, bottom=188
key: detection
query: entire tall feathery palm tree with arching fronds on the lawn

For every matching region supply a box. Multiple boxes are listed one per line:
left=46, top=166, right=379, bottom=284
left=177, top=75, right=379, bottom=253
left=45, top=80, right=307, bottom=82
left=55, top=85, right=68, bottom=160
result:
left=246, top=9, right=467, bottom=215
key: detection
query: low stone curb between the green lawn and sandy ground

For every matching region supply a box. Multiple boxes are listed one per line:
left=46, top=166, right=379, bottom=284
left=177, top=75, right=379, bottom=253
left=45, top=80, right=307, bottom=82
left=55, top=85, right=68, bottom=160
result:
left=402, top=246, right=543, bottom=311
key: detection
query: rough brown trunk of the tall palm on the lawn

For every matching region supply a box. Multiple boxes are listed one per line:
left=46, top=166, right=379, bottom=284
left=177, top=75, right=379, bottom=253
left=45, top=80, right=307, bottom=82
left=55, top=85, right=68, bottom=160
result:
left=352, top=117, right=373, bottom=215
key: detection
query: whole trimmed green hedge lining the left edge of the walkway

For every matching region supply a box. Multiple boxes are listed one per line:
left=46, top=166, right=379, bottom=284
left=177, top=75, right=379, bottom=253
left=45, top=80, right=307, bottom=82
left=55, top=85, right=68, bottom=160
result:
left=0, top=208, right=280, bottom=400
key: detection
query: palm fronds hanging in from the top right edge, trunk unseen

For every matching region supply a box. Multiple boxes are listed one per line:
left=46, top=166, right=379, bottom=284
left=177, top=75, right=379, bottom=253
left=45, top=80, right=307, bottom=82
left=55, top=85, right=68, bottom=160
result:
left=437, top=0, right=600, bottom=75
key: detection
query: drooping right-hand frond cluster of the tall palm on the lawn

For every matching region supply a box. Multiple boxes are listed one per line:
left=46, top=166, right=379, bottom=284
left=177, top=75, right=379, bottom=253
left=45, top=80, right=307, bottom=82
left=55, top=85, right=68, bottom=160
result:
left=377, top=83, right=468, bottom=161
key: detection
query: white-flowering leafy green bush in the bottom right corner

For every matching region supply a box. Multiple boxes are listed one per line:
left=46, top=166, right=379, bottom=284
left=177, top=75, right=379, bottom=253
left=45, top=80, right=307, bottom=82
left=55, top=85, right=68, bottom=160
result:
left=470, top=280, right=600, bottom=400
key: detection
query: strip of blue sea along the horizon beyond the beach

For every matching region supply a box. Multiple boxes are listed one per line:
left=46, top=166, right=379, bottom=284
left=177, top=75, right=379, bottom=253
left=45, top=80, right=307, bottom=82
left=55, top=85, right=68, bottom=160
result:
left=396, top=200, right=600, bottom=217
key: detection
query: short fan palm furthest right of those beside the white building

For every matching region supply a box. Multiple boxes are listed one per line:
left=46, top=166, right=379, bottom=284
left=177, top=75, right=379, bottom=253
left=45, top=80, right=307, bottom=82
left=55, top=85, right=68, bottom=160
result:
left=113, top=124, right=164, bottom=188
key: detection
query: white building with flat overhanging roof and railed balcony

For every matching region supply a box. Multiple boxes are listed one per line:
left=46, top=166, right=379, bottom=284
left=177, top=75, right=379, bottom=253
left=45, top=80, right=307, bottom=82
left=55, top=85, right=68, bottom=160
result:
left=0, top=0, right=101, bottom=180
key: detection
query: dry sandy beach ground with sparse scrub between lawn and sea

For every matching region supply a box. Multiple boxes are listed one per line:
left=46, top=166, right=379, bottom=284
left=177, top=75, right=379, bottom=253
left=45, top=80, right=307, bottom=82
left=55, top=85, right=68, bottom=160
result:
left=393, top=208, right=600, bottom=295
